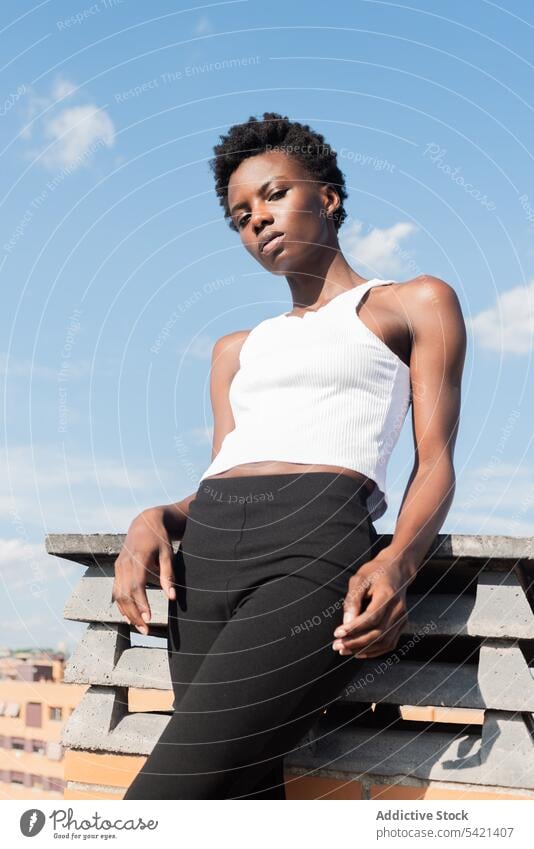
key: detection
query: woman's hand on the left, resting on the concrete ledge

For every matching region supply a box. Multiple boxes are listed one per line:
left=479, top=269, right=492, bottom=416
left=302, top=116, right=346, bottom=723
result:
left=111, top=507, right=176, bottom=634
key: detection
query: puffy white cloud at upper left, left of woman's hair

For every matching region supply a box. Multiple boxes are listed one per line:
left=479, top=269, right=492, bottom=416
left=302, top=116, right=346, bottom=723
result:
left=21, top=77, right=115, bottom=170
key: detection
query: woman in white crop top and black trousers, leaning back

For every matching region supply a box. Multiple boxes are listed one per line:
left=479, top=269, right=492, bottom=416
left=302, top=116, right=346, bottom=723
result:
left=113, top=113, right=465, bottom=799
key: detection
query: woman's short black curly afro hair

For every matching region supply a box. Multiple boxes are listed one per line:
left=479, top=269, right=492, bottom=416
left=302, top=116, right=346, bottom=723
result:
left=209, top=112, right=348, bottom=232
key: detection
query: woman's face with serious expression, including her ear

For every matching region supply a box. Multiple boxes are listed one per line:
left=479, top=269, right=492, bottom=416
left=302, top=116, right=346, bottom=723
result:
left=228, top=151, right=339, bottom=275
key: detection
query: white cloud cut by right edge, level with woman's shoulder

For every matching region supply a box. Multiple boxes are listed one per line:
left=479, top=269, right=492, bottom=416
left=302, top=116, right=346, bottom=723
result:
left=466, top=280, right=534, bottom=354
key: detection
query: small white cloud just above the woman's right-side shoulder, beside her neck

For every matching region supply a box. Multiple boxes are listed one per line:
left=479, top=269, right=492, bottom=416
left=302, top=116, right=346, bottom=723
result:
left=339, top=221, right=420, bottom=276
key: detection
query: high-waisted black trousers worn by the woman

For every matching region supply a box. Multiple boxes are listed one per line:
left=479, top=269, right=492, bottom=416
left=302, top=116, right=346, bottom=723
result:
left=124, top=472, right=378, bottom=799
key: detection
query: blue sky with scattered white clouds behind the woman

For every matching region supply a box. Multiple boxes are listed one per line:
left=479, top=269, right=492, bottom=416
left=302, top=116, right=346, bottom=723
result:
left=0, top=0, right=534, bottom=646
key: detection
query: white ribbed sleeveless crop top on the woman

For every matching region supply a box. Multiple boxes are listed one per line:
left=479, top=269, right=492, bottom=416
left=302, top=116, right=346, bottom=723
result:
left=200, top=278, right=411, bottom=520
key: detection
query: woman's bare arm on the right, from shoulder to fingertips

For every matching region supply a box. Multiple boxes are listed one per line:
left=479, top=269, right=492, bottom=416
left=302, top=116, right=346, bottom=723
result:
left=332, top=275, right=466, bottom=658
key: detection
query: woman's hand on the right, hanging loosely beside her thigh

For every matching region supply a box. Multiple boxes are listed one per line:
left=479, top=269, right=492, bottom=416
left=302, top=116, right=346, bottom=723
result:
left=332, top=551, right=410, bottom=658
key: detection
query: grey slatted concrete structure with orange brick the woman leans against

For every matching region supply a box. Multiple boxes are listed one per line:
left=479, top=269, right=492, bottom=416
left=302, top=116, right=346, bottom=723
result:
left=45, top=534, right=534, bottom=799
